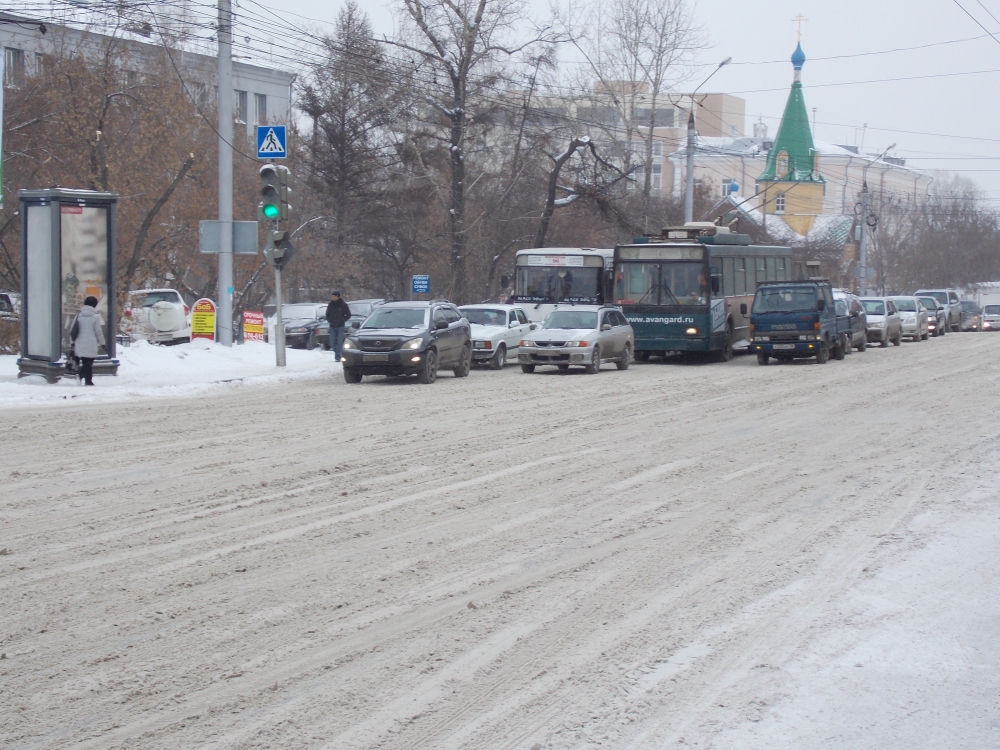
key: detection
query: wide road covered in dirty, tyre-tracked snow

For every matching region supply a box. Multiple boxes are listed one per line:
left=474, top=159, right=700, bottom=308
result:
left=0, top=334, right=1000, bottom=750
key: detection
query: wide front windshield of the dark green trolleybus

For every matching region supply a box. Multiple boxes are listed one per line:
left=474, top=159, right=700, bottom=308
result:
left=615, top=261, right=708, bottom=306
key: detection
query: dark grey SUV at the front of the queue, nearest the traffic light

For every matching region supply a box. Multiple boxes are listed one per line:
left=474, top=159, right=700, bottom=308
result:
left=343, top=300, right=472, bottom=383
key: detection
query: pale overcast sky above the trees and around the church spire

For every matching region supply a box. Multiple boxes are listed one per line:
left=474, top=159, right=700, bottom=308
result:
left=252, top=0, right=1000, bottom=201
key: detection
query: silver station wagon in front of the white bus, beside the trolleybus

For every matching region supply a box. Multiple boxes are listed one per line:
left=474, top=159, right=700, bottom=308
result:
left=517, top=305, right=635, bottom=374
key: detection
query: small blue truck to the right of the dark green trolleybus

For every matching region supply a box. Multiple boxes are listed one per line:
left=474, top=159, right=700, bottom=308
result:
left=750, top=279, right=849, bottom=365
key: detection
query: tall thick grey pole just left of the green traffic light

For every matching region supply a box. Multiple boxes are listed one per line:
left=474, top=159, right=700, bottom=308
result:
left=218, top=0, right=234, bottom=346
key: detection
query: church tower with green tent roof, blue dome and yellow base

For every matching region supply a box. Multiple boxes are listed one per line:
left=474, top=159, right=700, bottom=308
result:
left=757, top=44, right=826, bottom=235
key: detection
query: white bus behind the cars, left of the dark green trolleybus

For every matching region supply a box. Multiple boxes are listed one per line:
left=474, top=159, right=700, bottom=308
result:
left=510, top=247, right=615, bottom=322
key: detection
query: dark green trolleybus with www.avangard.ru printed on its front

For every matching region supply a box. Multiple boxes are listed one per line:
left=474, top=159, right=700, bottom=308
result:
left=613, top=222, right=793, bottom=362
